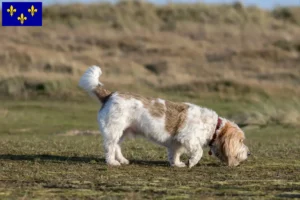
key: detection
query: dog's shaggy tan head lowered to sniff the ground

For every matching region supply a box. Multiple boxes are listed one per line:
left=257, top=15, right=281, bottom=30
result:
left=211, top=121, right=250, bottom=167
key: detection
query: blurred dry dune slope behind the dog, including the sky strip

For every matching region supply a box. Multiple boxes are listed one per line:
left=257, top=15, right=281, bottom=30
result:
left=0, top=0, right=300, bottom=124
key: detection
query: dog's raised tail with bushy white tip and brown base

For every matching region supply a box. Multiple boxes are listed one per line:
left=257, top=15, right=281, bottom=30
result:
left=79, top=66, right=112, bottom=103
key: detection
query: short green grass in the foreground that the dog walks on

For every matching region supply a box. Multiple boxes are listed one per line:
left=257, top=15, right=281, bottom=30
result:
left=0, top=100, right=300, bottom=199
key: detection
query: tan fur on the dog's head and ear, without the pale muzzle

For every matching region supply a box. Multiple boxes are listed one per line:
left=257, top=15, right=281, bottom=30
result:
left=217, top=122, right=244, bottom=166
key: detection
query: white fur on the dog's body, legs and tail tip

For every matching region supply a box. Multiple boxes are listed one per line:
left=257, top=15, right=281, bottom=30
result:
left=79, top=66, right=247, bottom=167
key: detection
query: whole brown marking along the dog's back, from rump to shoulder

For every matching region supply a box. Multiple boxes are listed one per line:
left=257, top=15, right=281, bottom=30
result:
left=119, top=93, right=189, bottom=135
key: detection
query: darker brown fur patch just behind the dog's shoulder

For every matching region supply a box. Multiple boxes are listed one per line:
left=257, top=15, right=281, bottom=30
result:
left=165, top=101, right=189, bottom=135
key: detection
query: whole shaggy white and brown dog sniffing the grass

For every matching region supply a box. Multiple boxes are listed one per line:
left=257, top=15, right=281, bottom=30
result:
left=79, top=66, right=250, bottom=168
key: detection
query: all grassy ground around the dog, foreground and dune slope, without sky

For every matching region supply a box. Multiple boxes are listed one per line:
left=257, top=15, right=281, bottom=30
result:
left=0, top=1, right=300, bottom=199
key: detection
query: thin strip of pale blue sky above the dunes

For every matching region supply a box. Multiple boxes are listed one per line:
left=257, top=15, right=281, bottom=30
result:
left=1, top=0, right=300, bottom=9
